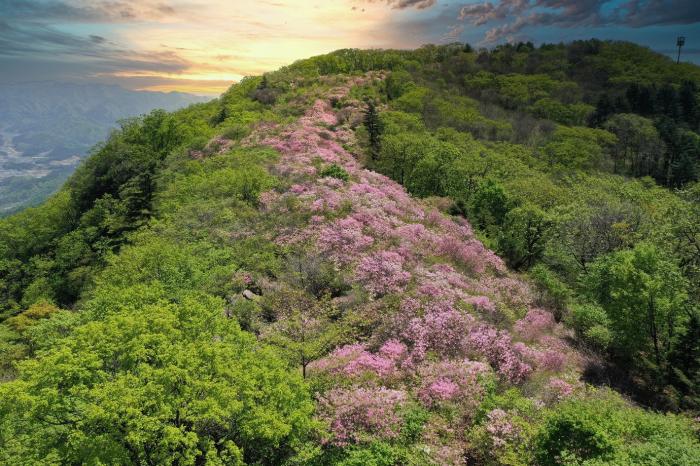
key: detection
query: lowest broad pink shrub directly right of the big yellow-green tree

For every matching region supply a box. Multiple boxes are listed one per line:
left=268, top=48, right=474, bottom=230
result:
left=318, top=387, right=407, bottom=446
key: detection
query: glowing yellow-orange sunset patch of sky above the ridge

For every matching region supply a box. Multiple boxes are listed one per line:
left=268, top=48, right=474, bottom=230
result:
left=105, top=0, right=404, bottom=94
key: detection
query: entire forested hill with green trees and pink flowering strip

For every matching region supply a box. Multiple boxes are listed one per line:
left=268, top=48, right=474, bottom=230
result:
left=0, top=40, right=700, bottom=466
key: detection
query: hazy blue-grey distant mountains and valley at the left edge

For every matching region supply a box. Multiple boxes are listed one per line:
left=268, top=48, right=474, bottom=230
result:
left=0, top=81, right=209, bottom=215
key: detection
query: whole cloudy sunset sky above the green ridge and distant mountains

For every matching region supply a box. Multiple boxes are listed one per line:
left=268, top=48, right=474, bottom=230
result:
left=0, top=0, right=700, bottom=95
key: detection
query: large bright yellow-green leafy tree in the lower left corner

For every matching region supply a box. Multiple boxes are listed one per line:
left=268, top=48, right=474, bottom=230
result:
left=0, top=295, right=312, bottom=464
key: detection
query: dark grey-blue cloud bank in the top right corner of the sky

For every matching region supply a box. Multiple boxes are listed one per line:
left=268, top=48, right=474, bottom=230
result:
left=459, top=0, right=700, bottom=42
